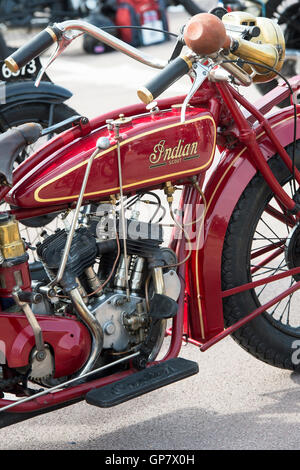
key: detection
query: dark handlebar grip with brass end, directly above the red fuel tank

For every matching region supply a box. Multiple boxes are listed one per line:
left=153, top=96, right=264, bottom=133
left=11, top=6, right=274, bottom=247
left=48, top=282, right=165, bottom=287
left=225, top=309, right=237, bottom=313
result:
left=137, top=56, right=193, bottom=104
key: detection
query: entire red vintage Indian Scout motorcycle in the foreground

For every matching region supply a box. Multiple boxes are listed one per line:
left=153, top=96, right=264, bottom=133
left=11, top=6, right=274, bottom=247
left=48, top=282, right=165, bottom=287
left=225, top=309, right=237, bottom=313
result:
left=0, top=12, right=300, bottom=427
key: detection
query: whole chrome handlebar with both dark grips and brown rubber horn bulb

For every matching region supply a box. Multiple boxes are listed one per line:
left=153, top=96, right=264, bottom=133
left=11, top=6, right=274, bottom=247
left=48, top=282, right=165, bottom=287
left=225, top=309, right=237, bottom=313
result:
left=5, top=13, right=278, bottom=104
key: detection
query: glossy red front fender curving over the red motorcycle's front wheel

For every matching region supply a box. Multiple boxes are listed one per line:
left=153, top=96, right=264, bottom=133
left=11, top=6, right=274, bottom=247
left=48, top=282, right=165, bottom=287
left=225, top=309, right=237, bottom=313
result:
left=187, top=107, right=300, bottom=343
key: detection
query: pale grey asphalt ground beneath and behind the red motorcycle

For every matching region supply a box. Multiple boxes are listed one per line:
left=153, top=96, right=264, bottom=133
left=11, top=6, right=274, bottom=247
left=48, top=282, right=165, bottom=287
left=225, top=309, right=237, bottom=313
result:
left=0, top=3, right=300, bottom=450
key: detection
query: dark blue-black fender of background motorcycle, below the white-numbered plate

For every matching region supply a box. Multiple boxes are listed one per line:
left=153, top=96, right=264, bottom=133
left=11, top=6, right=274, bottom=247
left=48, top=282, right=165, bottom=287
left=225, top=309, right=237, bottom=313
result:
left=0, top=80, right=72, bottom=111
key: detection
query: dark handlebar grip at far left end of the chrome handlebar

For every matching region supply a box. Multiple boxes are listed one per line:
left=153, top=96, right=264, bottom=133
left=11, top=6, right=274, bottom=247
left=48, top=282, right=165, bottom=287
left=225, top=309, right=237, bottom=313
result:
left=5, top=26, right=62, bottom=72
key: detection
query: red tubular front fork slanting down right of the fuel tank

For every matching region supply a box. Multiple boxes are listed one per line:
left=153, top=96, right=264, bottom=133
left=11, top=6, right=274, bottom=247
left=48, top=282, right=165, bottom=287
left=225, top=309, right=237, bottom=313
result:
left=216, top=82, right=300, bottom=221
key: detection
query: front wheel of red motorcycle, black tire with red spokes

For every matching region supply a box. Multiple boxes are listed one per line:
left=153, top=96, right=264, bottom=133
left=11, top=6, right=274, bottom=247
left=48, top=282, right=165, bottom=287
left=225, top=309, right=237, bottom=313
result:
left=222, top=141, right=300, bottom=370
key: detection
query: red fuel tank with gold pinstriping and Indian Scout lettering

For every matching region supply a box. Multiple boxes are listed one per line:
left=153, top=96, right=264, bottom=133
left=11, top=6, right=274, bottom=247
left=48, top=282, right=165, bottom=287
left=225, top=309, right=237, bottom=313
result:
left=6, top=106, right=216, bottom=208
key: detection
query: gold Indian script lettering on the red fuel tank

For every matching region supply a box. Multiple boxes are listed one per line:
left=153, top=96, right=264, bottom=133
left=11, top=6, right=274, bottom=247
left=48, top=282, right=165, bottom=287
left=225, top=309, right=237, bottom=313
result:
left=149, top=139, right=200, bottom=168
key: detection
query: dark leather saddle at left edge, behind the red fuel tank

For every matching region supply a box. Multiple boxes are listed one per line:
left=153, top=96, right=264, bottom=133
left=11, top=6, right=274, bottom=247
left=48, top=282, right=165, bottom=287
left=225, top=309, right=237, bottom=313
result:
left=0, top=122, right=42, bottom=186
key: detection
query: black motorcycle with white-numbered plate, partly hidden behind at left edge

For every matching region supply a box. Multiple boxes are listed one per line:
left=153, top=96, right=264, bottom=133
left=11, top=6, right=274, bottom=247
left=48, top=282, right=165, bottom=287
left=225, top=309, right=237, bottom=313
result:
left=0, top=30, right=82, bottom=277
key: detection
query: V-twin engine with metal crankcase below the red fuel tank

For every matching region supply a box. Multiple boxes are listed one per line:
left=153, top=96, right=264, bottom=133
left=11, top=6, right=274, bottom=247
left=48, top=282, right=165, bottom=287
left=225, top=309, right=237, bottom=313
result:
left=37, top=218, right=180, bottom=370
